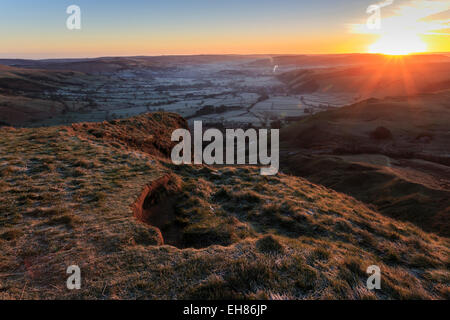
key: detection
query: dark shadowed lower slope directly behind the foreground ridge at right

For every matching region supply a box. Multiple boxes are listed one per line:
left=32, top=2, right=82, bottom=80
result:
left=282, top=154, right=450, bottom=236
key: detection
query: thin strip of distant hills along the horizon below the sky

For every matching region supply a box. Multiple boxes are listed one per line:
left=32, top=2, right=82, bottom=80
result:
left=0, top=54, right=450, bottom=73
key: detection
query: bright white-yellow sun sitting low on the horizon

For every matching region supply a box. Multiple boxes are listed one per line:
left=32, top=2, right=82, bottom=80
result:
left=369, top=34, right=427, bottom=55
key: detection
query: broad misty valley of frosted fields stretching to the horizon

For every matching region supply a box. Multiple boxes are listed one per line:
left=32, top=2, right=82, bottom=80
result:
left=5, top=55, right=450, bottom=127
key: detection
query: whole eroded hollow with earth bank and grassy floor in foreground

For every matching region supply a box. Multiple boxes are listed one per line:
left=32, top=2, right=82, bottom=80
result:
left=134, top=174, right=255, bottom=249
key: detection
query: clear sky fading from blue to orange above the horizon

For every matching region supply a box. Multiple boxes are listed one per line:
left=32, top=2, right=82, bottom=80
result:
left=0, top=0, right=450, bottom=59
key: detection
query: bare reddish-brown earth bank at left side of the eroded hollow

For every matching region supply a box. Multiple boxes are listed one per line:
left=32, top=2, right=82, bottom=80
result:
left=133, top=175, right=183, bottom=248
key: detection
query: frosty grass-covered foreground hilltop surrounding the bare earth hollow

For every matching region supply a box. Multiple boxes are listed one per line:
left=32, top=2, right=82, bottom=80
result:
left=0, top=114, right=449, bottom=299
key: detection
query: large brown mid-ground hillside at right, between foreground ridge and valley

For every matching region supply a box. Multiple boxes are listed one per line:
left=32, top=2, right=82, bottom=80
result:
left=281, top=91, right=450, bottom=236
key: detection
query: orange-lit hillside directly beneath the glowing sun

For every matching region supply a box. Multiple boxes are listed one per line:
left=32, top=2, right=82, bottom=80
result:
left=279, top=60, right=450, bottom=100
